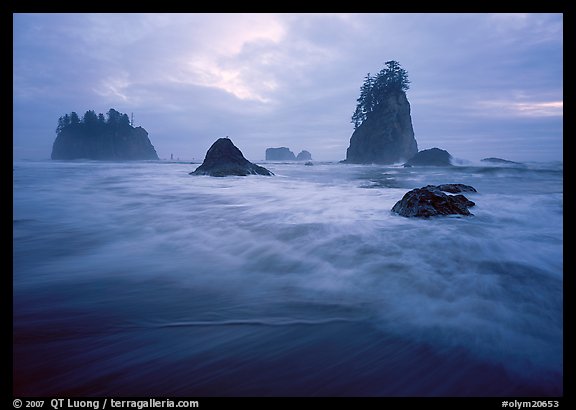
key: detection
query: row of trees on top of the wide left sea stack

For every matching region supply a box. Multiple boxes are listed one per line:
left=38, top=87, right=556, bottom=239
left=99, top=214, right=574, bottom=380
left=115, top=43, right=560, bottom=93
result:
left=56, top=108, right=131, bottom=134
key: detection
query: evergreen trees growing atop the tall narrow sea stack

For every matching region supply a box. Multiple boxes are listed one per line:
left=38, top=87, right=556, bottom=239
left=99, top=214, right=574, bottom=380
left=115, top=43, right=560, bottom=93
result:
left=351, top=60, right=410, bottom=129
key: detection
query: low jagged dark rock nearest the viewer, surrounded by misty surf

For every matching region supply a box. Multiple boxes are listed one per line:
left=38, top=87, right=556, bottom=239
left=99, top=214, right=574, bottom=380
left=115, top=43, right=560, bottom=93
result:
left=392, top=184, right=476, bottom=218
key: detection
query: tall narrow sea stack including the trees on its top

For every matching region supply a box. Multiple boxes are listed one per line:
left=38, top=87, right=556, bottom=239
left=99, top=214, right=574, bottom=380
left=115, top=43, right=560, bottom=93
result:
left=343, top=61, right=418, bottom=164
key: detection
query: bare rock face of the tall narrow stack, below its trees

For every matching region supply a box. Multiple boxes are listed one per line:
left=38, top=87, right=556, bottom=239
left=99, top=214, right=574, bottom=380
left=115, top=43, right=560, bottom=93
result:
left=342, top=90, right=418, bottom=164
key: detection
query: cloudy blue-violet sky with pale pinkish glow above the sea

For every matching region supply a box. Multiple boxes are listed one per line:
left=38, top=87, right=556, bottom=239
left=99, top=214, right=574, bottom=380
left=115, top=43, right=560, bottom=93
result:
left=13, top=13, right=563, bottom=161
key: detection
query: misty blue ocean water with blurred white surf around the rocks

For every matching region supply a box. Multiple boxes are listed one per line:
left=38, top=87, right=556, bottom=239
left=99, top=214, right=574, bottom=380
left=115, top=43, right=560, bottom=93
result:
left=13, top=161, right=563, bottom=397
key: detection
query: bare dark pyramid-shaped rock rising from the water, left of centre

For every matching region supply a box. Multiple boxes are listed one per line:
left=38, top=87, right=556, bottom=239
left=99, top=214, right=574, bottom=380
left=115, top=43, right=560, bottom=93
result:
left=190, top=137, right=274, bottom=177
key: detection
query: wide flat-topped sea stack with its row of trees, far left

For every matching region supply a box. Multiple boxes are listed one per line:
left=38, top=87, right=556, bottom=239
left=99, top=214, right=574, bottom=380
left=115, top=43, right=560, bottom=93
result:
left=51, top=109, right=159, bottom=160
